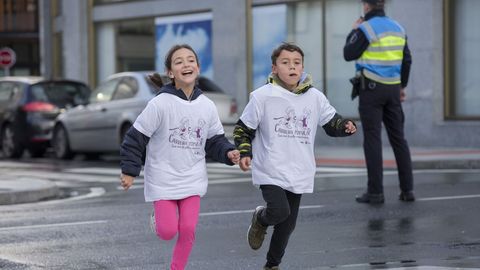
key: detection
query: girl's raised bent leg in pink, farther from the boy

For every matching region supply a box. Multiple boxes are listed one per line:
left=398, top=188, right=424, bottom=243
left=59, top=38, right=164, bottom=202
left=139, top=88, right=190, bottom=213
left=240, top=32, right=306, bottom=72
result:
left=153, top=200, right=178, bottom=240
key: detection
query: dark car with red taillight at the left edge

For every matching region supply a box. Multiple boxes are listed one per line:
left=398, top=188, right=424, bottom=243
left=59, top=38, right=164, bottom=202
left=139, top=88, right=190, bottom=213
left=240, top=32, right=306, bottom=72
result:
left=0, top=77, right=90, bottom=158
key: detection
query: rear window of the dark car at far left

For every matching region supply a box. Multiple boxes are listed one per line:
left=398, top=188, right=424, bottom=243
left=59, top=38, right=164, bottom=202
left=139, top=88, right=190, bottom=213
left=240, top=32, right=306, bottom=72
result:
left=31, top=82, right=90, bottom=108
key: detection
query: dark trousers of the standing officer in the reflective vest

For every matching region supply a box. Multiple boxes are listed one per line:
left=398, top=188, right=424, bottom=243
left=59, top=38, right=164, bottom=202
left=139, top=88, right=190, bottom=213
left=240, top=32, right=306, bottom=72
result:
left=358, top=79, right=413, bottom=194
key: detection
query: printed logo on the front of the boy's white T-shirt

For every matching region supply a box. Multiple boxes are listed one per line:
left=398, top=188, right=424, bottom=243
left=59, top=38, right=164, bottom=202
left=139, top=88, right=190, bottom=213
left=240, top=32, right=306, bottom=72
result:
left=273, top=107, right=312, bottom=144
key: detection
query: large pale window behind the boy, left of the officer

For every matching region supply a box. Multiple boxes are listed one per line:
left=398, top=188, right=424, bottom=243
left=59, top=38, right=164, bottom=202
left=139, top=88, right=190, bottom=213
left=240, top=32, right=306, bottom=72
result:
left=252, top=0, right=362, bottom=118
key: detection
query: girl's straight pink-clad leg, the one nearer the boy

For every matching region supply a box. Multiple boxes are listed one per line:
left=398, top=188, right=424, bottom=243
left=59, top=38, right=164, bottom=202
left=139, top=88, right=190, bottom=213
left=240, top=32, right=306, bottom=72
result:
left=171, top=196, right=200, bottom=270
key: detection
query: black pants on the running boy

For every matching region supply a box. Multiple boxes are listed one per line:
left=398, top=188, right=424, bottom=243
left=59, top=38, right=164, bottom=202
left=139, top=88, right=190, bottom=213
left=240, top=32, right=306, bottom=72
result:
left=259, top=185, right=302, bottom=267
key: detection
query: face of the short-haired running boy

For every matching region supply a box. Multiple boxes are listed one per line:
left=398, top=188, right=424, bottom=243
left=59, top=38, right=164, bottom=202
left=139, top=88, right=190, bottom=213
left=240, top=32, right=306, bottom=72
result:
left=272, top=50, right=303, bottom=90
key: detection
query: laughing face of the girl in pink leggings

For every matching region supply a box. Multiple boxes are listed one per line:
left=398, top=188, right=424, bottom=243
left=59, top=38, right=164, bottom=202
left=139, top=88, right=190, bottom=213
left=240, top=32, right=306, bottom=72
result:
left=168, top=48, right=200, bottom=89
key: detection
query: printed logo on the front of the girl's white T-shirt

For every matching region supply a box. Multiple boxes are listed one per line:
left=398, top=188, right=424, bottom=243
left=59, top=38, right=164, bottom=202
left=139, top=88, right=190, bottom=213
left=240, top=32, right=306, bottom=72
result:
left=168, top=117, right=207, bottom=150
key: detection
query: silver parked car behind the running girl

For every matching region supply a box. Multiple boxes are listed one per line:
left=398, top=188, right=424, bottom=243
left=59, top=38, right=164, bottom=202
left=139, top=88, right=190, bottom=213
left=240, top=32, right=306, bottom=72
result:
left=52, top=72, right=238, bottom=159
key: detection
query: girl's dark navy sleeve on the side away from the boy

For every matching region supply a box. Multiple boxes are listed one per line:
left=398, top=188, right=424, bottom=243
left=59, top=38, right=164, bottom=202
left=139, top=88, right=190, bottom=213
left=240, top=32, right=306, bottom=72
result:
left=120, top=126, right=150, bottom=177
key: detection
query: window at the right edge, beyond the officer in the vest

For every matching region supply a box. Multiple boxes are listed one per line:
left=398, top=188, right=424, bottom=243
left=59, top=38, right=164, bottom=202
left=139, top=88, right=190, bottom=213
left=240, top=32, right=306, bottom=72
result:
left=444, top=0, right=480, bottom=120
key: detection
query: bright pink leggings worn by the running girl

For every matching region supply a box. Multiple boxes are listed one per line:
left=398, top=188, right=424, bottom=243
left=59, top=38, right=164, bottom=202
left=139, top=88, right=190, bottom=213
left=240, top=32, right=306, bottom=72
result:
left=153, top=196, right=200, bottom=270
